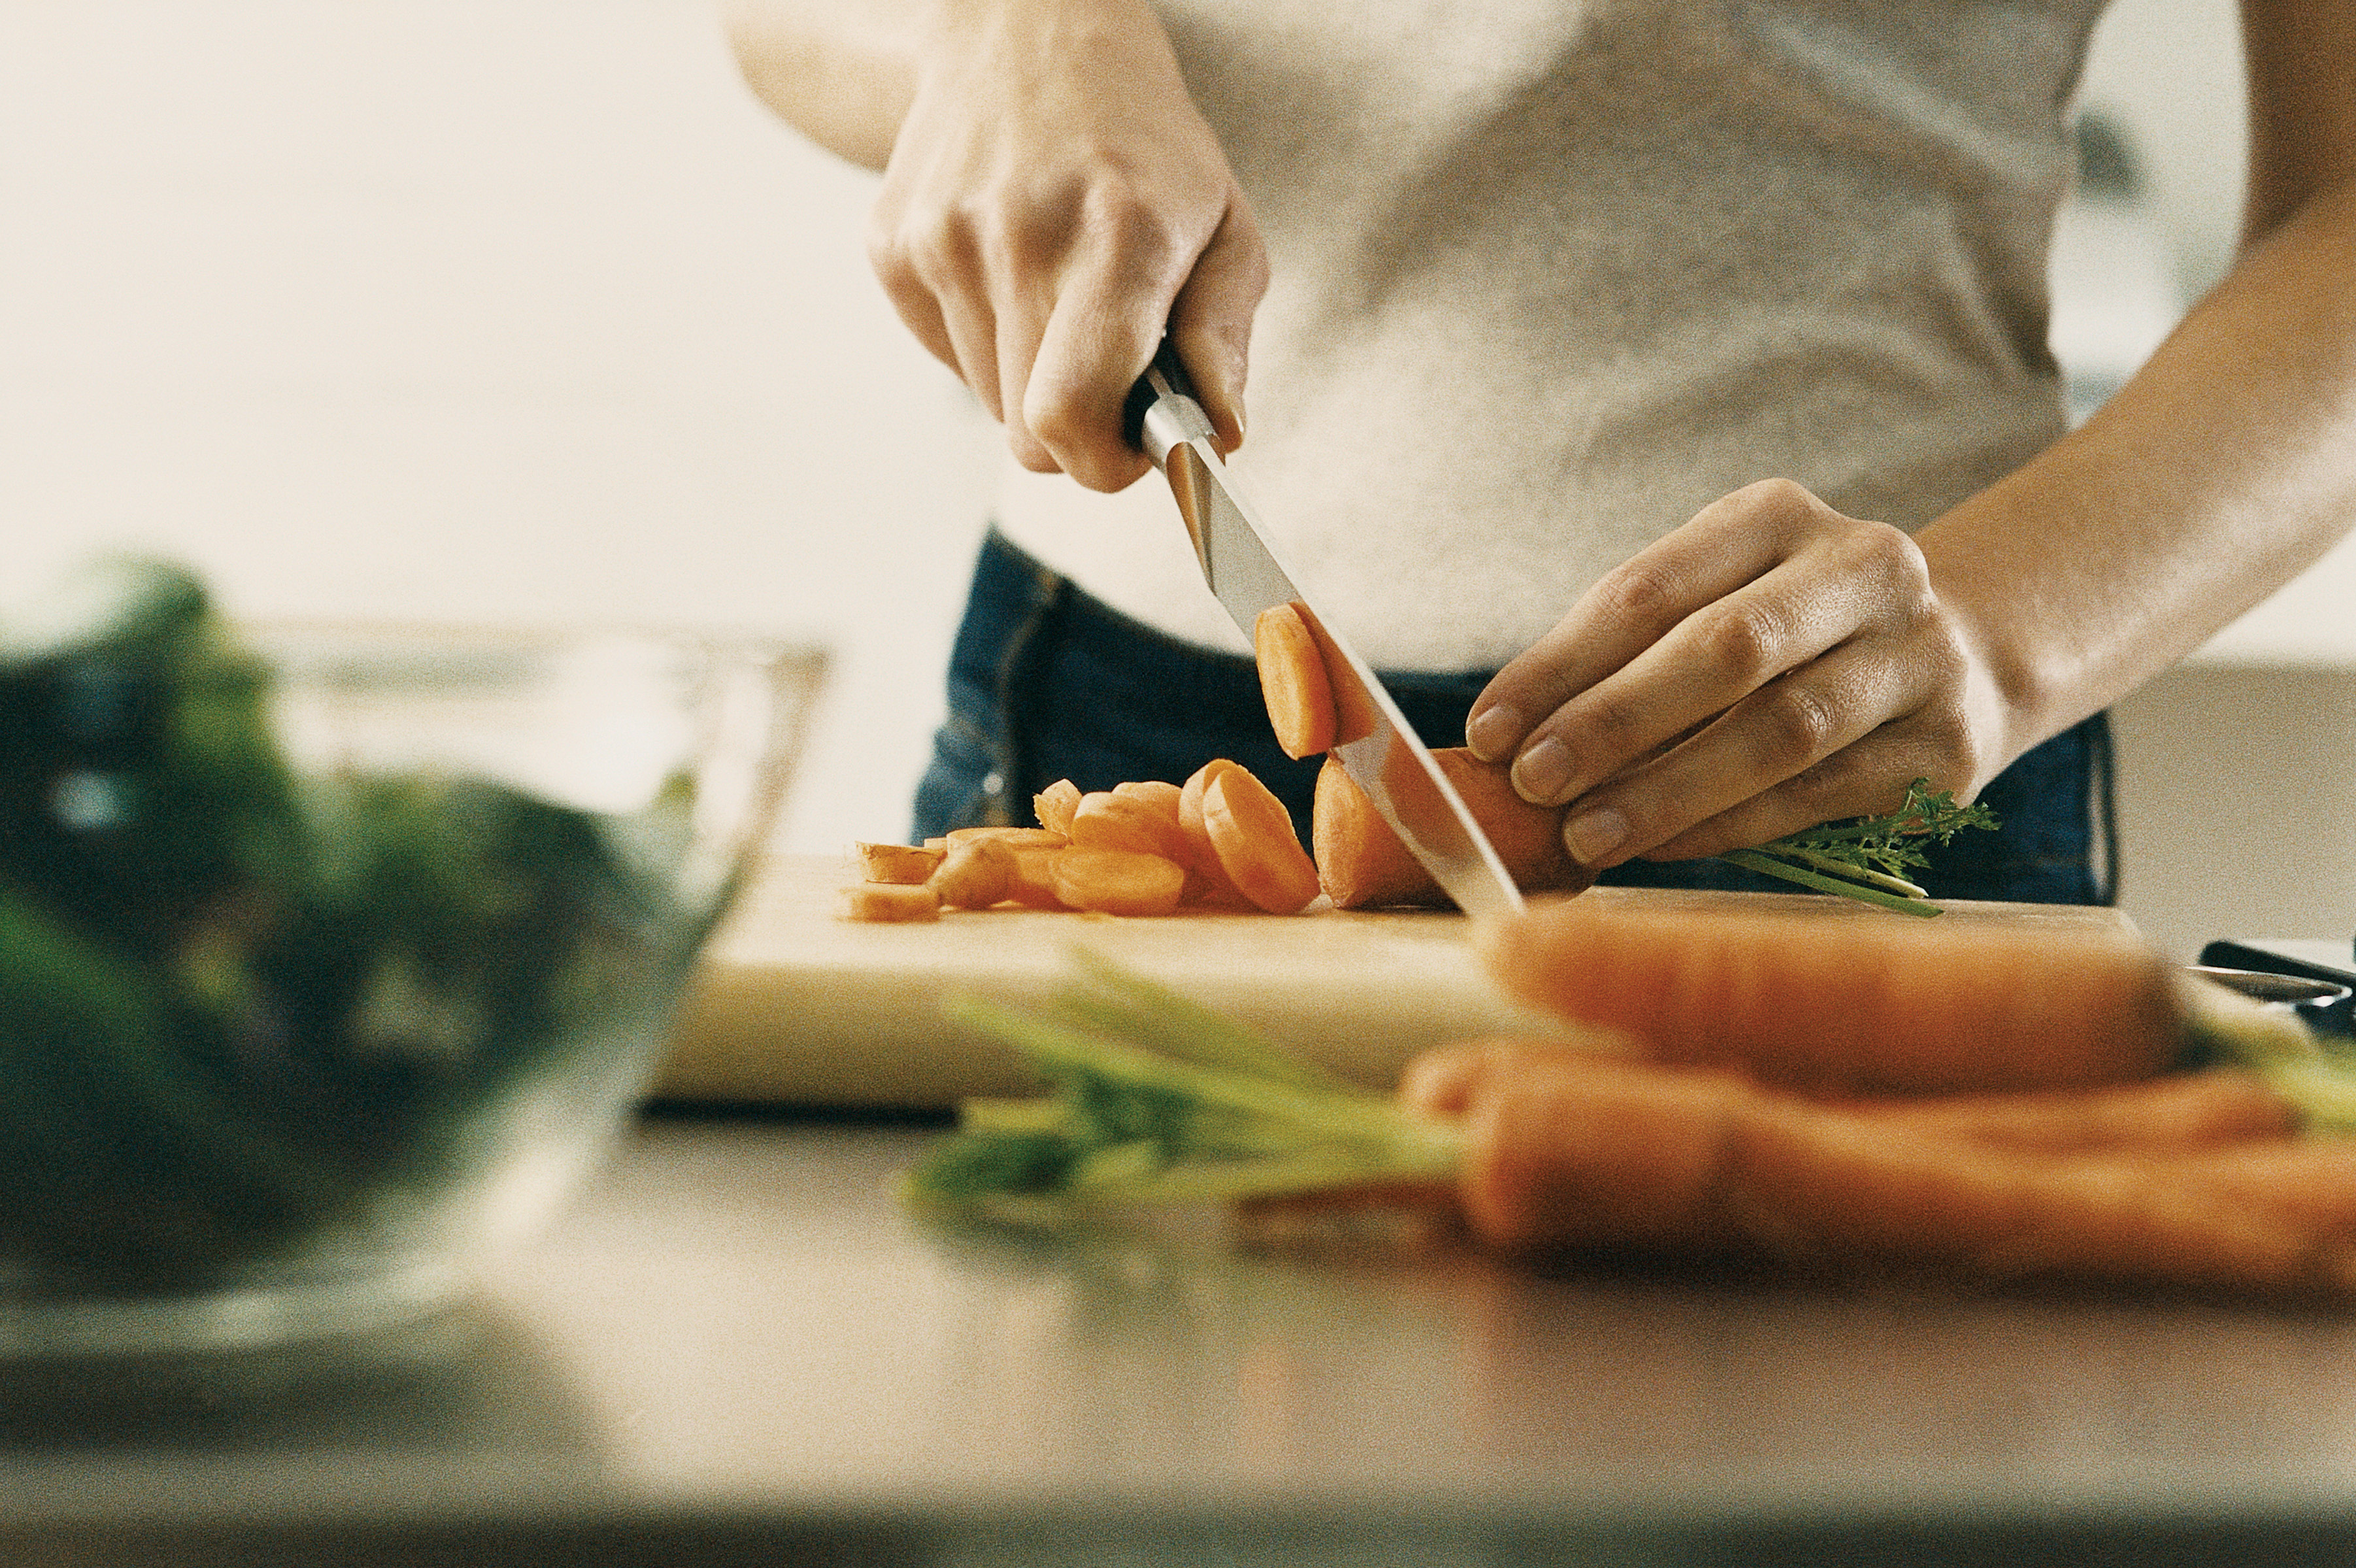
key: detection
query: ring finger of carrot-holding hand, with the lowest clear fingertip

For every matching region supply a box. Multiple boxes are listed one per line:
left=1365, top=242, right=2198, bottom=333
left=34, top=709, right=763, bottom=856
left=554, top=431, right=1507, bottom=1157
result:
left=1562, top=645, right=1953, bottom=871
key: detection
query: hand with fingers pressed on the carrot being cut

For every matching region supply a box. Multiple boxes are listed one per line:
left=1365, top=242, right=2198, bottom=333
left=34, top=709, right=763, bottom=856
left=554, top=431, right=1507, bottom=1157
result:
left=1466, top=480, right=2005, bottom=869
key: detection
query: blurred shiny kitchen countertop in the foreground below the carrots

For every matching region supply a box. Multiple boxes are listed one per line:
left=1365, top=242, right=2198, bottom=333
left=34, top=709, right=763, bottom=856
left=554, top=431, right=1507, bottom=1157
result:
left=14, top=1114, right=2356, bottom=1568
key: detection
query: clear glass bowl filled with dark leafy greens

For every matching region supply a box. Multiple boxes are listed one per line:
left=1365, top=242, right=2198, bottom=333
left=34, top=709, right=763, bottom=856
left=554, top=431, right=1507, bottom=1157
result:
left=0, top=560, right=822, bottom=1356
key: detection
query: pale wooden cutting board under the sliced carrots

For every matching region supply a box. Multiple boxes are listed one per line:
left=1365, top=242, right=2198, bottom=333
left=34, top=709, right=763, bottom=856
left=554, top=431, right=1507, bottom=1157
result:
left=658, top=857, right=2158, bottom=1109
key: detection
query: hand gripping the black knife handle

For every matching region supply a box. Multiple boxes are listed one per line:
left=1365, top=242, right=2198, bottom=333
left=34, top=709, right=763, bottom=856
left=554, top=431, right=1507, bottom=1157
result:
left=869, top=0, right=1268, bottom=490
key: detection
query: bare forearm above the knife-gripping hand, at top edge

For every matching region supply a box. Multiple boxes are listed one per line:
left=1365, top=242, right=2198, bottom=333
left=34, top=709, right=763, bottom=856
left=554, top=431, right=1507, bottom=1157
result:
left=721, top=0, right=931, bottom=169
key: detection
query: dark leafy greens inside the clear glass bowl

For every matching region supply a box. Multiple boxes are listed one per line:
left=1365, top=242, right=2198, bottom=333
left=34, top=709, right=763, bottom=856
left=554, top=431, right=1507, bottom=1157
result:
left=0, top=560, right=711, bottom=1288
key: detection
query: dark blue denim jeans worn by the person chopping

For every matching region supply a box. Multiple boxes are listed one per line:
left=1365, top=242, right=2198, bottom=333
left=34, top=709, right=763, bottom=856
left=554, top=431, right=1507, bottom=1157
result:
left=914, top=535, right=2115, bottom=904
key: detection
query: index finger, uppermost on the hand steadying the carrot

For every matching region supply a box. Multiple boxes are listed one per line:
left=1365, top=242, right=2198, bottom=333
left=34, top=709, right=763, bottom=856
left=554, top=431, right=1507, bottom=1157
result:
left=1466, top=480, right=1838, bottom=763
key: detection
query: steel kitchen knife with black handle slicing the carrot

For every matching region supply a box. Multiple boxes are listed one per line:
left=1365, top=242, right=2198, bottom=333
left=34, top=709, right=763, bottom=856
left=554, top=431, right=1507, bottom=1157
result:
left=1124, top=339, right=1522, bottom=916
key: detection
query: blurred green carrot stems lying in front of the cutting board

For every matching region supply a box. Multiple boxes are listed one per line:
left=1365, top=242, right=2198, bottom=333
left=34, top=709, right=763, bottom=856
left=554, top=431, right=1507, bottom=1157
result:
left=902, top=954, right=1463, bottom=1217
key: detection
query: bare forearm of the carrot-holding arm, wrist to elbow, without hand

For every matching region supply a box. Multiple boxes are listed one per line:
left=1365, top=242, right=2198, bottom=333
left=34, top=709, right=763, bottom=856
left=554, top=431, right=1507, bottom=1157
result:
left=1918, top=181, right=2356, bottom=760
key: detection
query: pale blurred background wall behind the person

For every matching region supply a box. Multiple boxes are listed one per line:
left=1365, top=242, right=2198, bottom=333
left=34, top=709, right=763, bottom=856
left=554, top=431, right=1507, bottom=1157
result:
left=0, top=0, right=2356, bottom=956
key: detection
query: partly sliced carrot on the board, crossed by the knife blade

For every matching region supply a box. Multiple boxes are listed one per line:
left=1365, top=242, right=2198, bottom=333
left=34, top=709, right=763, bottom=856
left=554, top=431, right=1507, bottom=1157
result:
left=1310, top=746, right=1595, bottom=909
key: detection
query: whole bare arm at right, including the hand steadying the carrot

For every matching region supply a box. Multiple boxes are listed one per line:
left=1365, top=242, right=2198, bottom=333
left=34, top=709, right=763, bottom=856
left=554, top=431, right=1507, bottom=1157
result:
left=1468, top=0, right=2356, bottom=867
